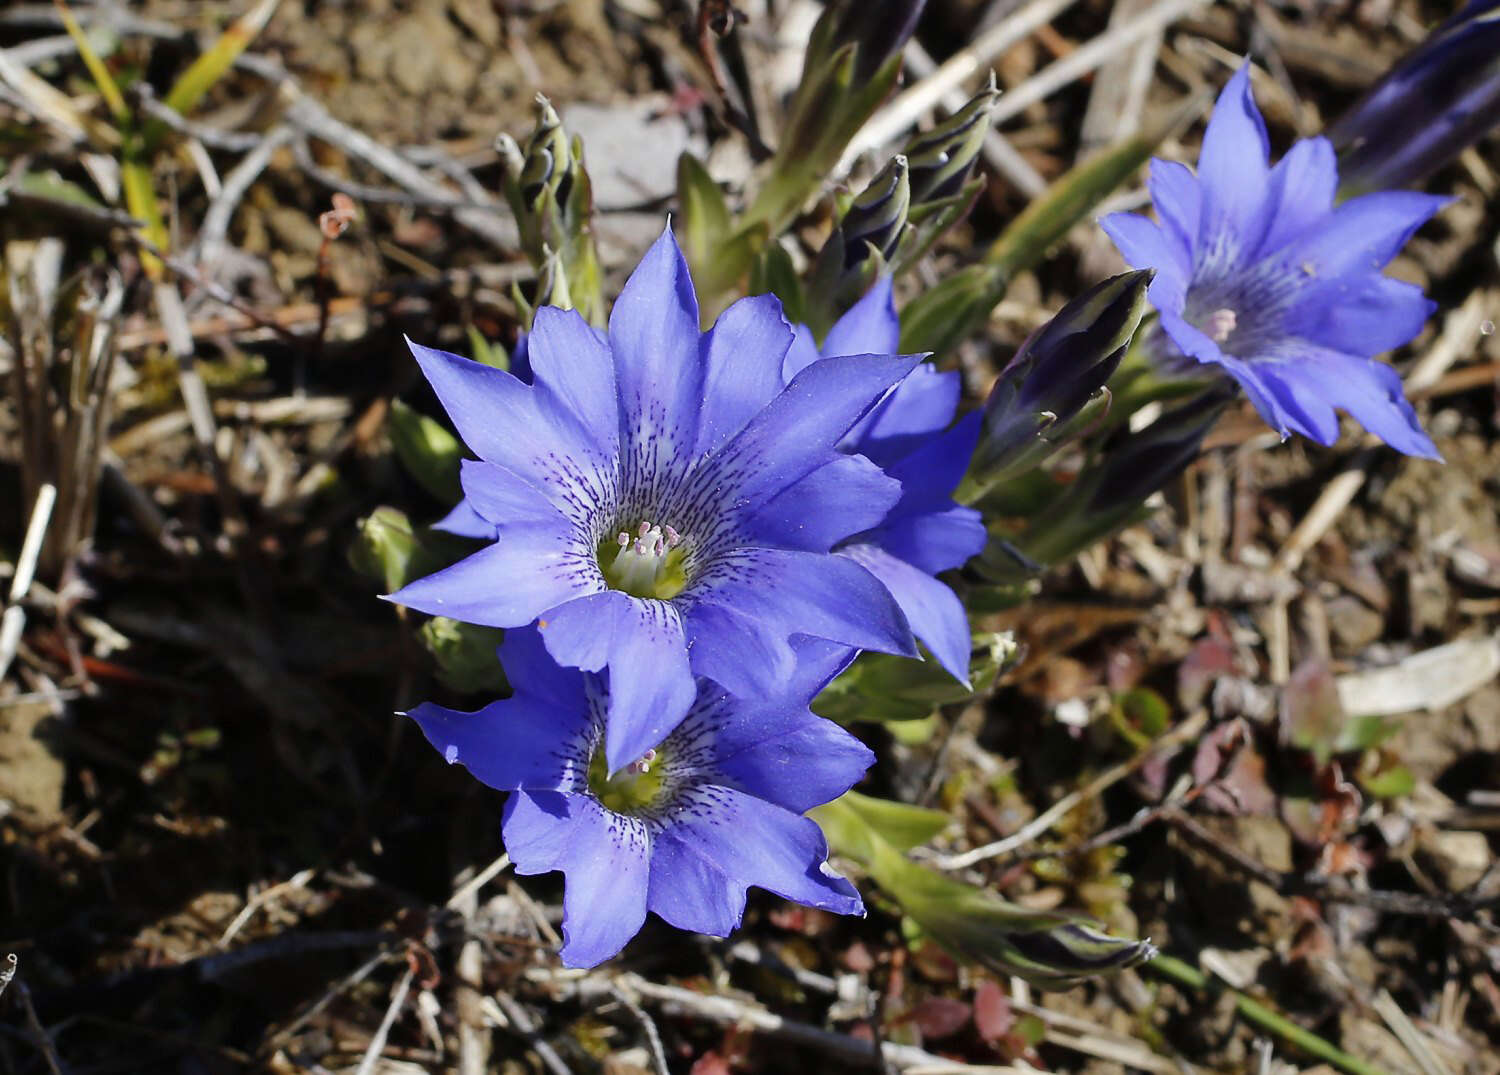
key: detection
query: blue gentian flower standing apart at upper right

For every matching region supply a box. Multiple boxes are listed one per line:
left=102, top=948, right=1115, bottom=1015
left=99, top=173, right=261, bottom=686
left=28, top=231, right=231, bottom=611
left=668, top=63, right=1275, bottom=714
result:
left=1103, top=64, right=1445, bottom=459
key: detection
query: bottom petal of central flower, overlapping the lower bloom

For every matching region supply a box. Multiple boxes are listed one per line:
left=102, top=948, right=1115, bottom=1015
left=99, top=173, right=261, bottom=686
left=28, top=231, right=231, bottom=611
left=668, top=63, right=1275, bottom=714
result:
left=539, top=589, right=696, bottom=772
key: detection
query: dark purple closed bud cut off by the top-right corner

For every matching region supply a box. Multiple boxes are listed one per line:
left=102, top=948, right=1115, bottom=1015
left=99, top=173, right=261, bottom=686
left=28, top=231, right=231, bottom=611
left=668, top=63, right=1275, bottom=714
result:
left=1328, top=0, right=1500, bottom=195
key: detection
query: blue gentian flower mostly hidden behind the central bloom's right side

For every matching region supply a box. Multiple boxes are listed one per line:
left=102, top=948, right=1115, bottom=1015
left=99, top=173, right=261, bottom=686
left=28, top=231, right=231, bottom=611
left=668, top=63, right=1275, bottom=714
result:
left=783, top=276, right=986, bottom=684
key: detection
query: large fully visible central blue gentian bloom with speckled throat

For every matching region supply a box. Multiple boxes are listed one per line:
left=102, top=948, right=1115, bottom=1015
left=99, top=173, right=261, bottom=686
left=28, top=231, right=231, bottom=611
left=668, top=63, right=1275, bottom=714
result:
left=392, top=231, right=918, bottom=772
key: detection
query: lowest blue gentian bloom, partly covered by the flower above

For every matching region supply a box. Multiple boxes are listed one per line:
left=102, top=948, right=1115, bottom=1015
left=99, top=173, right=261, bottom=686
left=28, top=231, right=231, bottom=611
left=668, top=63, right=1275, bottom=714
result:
left=411, top=628, right=875, bottom=967
